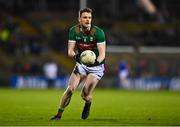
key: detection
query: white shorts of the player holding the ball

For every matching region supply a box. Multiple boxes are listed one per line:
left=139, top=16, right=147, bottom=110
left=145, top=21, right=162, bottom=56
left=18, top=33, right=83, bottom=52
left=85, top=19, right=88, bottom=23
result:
left=76, top=63, right=105, bottom=80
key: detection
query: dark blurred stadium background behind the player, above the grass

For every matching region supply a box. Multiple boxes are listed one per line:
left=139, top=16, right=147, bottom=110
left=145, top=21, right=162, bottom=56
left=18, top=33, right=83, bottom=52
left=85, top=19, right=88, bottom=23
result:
left=0, top=0, right=180, bottom=90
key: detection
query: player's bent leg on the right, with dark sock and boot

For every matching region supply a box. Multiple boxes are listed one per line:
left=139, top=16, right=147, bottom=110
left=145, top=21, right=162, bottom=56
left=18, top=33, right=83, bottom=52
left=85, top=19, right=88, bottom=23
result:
left=81, top=74, right=99, bottom=119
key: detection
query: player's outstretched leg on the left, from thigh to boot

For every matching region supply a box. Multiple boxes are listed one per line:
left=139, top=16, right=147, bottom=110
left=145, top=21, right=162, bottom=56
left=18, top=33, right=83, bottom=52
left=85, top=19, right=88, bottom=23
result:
left=51, top=70, right=81, bottom=120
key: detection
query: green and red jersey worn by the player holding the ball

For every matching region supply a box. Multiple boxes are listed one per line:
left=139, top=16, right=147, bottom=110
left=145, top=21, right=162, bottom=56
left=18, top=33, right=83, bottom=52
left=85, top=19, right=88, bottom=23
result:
left=69, top=24, right=106, bottom=63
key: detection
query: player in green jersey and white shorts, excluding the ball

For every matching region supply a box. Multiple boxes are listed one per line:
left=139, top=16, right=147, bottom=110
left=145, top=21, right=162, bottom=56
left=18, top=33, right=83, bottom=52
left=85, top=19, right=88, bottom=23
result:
left=51, top=8, right=106, bottom=120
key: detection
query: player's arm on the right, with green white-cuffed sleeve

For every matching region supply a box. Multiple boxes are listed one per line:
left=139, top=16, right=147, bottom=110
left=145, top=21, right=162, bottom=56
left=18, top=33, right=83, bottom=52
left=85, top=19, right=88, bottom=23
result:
left=97, top=30, right=106, bottom=63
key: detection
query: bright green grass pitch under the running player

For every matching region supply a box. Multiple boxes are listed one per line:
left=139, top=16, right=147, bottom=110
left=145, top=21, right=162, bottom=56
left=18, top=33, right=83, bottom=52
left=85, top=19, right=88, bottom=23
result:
left=0, top=89, right=180, bottom=126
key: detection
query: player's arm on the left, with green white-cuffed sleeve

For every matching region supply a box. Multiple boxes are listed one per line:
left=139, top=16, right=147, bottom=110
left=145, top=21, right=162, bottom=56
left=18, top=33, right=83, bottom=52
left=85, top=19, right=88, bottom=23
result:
left=68, top=27, right=76, bottom=57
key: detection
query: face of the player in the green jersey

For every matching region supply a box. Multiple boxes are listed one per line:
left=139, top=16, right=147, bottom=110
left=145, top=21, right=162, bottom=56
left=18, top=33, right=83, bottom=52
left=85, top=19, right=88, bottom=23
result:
left=79, top=12, right=92, bottom=28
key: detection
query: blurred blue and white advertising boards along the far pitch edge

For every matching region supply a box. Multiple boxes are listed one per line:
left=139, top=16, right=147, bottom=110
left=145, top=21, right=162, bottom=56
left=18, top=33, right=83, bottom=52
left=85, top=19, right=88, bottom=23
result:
left=10, top=75, right=180, bottom=91
